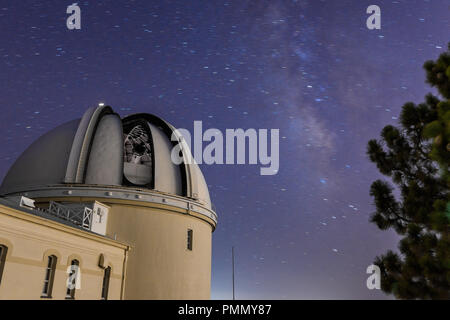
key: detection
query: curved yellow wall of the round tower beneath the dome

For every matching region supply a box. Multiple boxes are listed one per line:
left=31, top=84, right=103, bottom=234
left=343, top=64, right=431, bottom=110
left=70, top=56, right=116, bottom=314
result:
left=107, top=201, right=212, bottom=299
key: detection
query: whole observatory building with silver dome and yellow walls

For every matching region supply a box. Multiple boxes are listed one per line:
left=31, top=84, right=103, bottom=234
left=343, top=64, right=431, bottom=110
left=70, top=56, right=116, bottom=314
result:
left=0, top=105, right=217, bottom=299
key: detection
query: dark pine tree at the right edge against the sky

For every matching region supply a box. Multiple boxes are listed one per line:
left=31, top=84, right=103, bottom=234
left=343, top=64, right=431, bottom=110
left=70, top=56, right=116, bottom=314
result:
left=367, top=43, right=450, bottom=299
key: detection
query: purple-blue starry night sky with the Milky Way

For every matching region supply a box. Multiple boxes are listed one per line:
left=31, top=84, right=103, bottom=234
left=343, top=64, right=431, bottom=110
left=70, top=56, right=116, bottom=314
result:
left=0, top=0, right=450, bottom=299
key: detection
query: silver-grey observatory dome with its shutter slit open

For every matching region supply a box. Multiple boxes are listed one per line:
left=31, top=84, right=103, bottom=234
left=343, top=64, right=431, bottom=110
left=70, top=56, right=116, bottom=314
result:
left=0, top=106, right=211, bottom=209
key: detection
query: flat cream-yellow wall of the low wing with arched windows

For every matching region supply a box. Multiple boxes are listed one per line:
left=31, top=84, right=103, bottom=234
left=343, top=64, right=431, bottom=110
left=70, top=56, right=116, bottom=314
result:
left=0, top=205, right=128, bottom=300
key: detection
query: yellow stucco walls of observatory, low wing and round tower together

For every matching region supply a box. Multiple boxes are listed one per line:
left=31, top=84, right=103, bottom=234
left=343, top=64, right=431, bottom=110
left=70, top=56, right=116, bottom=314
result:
left=0, top=197, right=215, bottom=300
